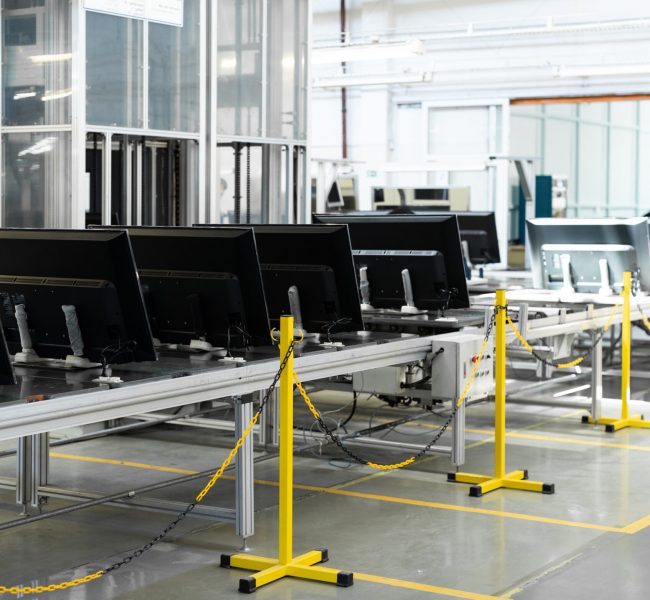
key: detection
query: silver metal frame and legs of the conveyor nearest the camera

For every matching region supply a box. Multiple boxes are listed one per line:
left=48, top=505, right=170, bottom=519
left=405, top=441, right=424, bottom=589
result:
left=0, top=336, right=433, bottom=539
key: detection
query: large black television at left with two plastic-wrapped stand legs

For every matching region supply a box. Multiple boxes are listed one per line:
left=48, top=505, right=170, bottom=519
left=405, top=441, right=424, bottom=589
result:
left=0, top=229, right=156, bottom=363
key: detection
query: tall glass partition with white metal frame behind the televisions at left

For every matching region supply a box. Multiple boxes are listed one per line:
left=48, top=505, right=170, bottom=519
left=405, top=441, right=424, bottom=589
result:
left=0, top=0, right=309, bottom=227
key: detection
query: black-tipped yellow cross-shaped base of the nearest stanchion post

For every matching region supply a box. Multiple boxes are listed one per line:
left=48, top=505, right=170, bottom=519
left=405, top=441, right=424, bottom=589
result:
left=221, top=550, right=353, bottom=594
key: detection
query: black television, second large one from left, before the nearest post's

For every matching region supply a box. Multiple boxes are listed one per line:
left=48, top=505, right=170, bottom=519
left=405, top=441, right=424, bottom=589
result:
left=95, top=227, right=271, bottom=350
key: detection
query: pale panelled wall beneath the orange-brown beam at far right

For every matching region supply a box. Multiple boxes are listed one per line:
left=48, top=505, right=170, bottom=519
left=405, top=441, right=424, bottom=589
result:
left=511, top=101, right=650, bottom=217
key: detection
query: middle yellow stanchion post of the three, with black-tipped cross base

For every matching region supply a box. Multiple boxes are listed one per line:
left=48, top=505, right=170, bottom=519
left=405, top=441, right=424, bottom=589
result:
left=447, top=290, right=555, bottom=498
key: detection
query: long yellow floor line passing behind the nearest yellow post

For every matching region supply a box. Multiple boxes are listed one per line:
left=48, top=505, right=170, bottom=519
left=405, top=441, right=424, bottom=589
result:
left=50, top=452, right=632, bottom=533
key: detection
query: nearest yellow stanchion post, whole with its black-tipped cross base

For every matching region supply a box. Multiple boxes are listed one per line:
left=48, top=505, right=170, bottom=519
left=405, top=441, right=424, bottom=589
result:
left=221, top=316, right=353, bottom=594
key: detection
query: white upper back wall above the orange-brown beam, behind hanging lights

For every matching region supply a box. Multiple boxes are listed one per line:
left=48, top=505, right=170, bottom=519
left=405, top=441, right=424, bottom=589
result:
left=311, top=0, right=650, bottom=168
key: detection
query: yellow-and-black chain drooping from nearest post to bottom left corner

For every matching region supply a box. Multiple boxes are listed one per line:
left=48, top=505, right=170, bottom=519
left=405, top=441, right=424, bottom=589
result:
left=0, top=341, right=295, bottom=596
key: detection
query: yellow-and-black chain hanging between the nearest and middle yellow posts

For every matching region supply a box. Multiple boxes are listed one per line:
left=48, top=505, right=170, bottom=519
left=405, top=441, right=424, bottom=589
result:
left=293, top=306, right=496, bottom=471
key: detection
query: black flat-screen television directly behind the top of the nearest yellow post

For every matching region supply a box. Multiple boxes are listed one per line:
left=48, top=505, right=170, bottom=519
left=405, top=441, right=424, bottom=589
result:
left=195, top=225, right=363, bottom=333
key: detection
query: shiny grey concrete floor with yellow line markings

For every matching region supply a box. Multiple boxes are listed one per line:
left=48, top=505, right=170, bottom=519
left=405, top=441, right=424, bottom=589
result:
left=0, top=372, right=650, bottom=600
